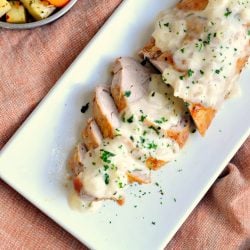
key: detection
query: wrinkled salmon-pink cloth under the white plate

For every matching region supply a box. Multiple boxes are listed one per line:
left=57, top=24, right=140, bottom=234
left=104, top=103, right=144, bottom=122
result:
left=0, top=0, right=250, bottom=249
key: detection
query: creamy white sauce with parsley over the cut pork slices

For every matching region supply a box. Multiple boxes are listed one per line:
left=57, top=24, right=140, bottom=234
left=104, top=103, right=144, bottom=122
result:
left=75, top=75, right=187, bottom=207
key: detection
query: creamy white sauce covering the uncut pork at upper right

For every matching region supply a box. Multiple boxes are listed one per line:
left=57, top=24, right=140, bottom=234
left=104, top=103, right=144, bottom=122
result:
left=153, top=0, right=250, bottom=109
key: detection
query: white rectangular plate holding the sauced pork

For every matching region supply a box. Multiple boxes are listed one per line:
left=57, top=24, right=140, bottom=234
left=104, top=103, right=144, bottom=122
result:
left=0, top=0, right=250, bottom=250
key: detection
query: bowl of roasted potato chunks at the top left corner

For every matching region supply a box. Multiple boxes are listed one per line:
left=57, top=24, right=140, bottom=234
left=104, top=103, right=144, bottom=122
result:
left=0, top=0, right=77, bottom=29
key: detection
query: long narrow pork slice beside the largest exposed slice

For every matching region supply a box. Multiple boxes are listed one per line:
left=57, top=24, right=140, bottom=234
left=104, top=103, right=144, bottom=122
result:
left=93, top=85, right=120, bottom=138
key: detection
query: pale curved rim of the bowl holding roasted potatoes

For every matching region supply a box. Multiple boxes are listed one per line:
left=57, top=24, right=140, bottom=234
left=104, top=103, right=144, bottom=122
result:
left=0, top=0, right=77, bottom=30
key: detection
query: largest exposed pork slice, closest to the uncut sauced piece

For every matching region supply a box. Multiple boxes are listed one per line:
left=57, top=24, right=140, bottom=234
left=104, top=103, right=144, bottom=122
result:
left=111, top=57, right=150, bottom=112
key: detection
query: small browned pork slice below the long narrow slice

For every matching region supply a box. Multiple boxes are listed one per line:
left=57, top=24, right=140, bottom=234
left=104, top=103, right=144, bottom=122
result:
left=82, top=118, right=103, bottom=150
